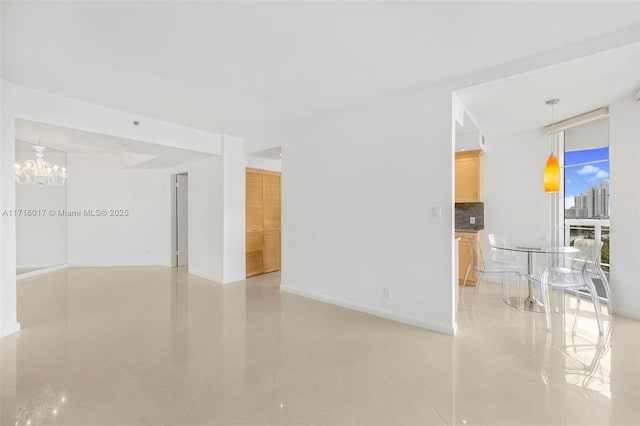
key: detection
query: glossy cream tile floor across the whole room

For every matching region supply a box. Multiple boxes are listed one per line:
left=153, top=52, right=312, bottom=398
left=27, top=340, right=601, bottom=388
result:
left=0, top=267, right=640, bottom=426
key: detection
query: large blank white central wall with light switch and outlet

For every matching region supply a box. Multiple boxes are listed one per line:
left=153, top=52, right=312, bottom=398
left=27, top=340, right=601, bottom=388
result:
left=267, top=87, right=455, bottom=334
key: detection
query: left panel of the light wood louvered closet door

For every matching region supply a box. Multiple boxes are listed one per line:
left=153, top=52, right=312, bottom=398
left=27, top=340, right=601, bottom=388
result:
left=245, top=170, right=264, bottom=277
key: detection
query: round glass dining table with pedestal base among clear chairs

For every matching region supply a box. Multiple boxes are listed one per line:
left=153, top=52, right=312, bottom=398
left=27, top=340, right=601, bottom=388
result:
left=491, top=242, right=579, bottom=312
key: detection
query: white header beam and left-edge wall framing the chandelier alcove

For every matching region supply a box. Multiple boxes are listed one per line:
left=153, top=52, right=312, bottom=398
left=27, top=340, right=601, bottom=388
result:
left=0, top=80, right=222, bottom=336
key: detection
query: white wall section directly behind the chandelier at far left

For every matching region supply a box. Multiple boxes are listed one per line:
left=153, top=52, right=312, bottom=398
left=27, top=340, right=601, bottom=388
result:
left=16, top=150, right=67, bottom=268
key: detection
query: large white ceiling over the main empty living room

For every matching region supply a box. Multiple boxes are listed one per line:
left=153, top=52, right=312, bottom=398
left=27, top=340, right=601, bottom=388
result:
left=0, top=1, right=640, bottom=136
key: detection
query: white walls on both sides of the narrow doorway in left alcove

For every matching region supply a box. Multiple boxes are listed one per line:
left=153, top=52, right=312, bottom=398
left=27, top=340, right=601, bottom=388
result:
left=68, top=146, right=245, bottom=284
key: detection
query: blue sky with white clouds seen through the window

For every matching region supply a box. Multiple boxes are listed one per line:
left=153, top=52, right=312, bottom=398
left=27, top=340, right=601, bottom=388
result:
left=564, top=147, right=609, bottom=209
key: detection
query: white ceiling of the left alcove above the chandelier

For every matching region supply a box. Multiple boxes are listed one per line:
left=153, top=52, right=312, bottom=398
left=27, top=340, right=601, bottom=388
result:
left=16, top=119, right=209, bottom=169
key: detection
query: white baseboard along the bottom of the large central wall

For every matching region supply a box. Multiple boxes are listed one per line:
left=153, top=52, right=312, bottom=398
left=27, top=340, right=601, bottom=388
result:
left=280, top=285, right=458, bottom=336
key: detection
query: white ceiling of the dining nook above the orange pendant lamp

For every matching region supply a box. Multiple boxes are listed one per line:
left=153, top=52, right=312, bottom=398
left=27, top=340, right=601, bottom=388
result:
left=457, top=43, right=640, bottom=136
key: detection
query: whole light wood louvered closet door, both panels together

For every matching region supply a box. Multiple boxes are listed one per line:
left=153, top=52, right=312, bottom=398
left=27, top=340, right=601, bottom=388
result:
left=245, top=169, right=281, bottom=277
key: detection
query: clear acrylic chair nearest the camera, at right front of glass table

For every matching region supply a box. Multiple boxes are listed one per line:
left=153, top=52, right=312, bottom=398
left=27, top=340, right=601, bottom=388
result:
left=527, top=241, right=604, bottom=335
